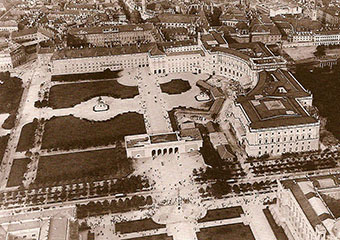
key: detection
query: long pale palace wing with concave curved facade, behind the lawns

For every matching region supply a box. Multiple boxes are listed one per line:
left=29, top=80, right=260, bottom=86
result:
left=51, top=32, right=286, bottom=81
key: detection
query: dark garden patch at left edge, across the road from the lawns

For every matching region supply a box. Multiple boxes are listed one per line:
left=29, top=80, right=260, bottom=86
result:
left=0, top=72, right=24, bottom=129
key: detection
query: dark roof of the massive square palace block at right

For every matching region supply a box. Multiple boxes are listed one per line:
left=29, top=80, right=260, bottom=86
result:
left=237, top=70, right=317, bottom=129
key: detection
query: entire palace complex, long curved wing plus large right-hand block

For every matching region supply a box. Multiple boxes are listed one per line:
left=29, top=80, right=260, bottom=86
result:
left=50, top=32, right=320, bottom=157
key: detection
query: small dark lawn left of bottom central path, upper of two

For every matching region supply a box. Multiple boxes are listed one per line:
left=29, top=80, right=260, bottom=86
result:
left=116, top=218, right=165, bottom=233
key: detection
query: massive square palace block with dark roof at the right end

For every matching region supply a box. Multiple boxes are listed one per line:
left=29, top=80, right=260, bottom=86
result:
left=233, top=69, right=320, bottom=157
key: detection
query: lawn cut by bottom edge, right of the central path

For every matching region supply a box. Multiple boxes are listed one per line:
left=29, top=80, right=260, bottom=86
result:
left=197, top=223, right=255, bottom=240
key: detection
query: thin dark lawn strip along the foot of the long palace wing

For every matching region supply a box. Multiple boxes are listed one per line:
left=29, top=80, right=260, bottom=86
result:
left=51, top=70, right=120, bottom=82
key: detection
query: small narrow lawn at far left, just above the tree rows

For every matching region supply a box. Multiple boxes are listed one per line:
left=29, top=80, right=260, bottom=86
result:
left=7, top=158, right=31, bottom=187
